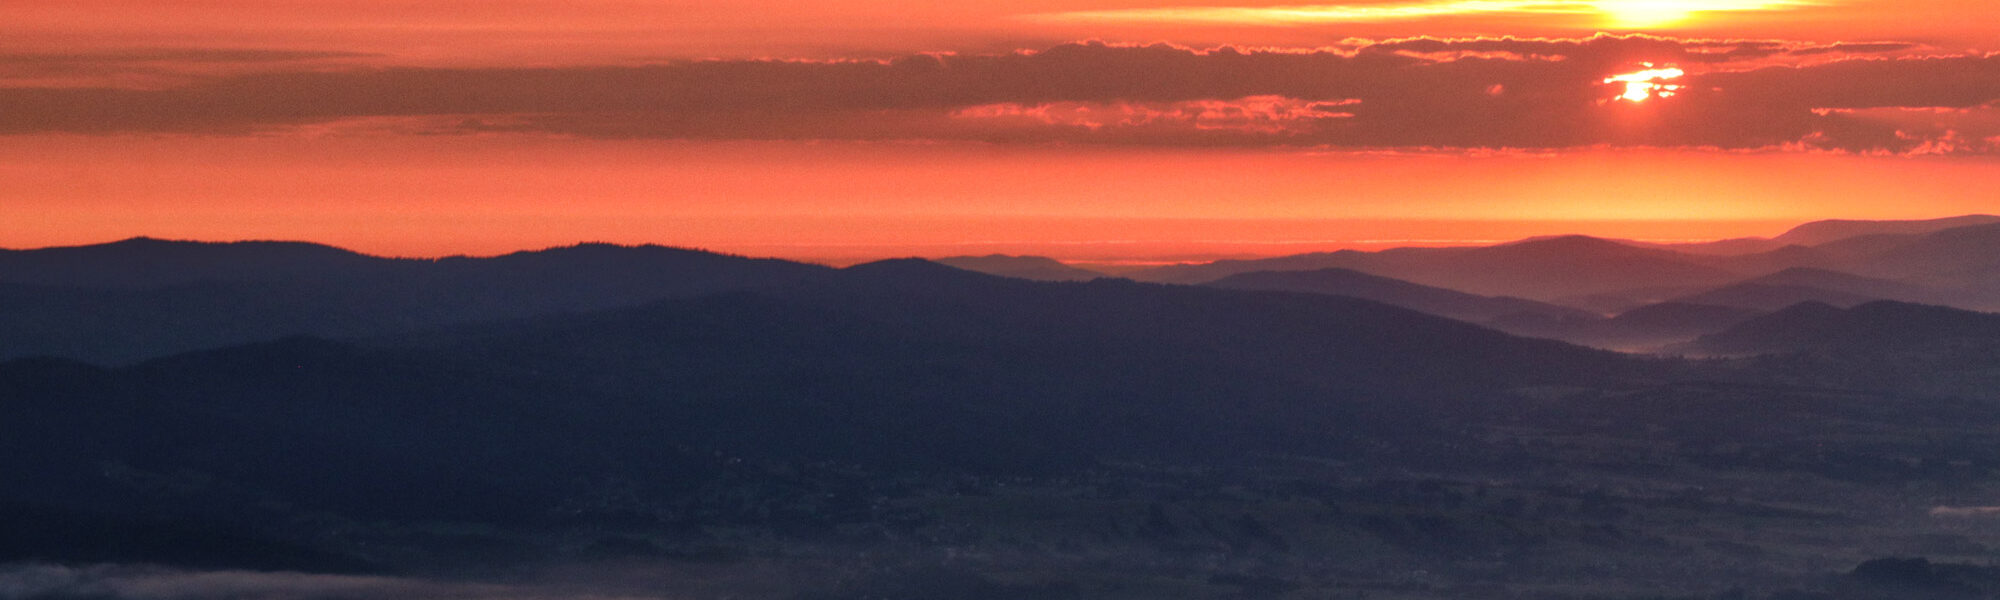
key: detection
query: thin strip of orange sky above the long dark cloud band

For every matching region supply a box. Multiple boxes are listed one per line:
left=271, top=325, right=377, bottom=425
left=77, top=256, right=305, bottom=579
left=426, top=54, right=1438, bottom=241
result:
left=15, top=0, right=2000, bottom=64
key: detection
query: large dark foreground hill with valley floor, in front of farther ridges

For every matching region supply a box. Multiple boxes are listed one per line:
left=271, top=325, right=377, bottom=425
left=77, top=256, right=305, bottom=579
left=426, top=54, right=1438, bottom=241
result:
left=19, top=248, right=2000, bottom=598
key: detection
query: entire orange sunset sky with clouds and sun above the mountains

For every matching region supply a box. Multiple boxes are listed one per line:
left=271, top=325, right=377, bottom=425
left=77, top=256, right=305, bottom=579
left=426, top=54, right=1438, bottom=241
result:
left=0, top=0, right=2000, bottom=262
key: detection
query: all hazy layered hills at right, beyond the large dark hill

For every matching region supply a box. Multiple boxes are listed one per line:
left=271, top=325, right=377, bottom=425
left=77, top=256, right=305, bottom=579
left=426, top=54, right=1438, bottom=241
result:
left=928, top=214, right=2000, bottom=350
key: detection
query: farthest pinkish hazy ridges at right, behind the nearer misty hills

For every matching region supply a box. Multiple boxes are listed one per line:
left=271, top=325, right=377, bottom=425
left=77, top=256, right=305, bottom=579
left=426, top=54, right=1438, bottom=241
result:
left=1130, top=216, right=2000, bottom=312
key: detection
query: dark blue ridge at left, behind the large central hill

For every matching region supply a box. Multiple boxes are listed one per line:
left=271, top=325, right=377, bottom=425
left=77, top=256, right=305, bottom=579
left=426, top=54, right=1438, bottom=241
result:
left=0, top=238, right=830, bottom=364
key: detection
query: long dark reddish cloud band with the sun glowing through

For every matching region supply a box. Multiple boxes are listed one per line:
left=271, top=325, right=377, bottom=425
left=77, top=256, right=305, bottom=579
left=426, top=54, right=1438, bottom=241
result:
left=0, top=36, right=2000, bottom=154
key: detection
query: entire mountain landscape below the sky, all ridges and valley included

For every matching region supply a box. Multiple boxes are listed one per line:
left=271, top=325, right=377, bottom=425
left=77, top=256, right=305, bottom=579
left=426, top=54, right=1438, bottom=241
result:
left=11, top=218, right=2000, bottom=600
